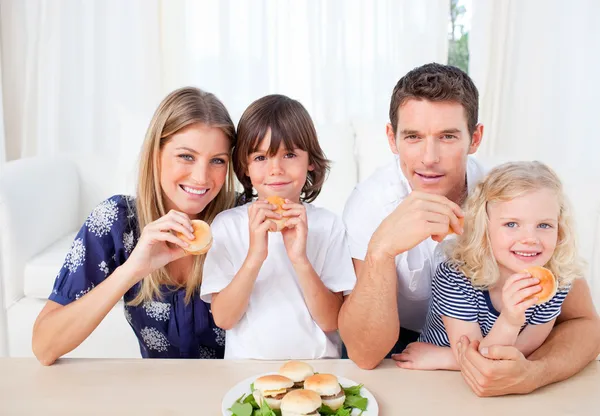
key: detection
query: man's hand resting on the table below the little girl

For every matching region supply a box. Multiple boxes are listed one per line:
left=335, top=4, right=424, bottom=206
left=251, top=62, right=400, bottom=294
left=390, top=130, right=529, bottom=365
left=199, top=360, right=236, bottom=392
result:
left=458, top=336, right=542, bottom=397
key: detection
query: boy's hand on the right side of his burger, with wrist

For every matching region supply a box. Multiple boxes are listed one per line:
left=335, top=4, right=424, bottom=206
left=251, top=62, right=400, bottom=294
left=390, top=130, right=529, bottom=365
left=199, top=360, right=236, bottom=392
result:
left=281, top=199, right=308, bottom=265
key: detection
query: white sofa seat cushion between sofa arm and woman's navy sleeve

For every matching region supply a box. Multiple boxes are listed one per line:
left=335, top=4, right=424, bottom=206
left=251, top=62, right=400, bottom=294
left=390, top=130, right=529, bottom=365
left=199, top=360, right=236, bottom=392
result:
left=24, top=233, right=77, bottom=299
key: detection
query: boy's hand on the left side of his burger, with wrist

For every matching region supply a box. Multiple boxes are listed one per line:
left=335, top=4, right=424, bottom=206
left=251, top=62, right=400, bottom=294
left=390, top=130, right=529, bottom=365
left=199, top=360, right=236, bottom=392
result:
left=248, top=200, right=281, bottom=264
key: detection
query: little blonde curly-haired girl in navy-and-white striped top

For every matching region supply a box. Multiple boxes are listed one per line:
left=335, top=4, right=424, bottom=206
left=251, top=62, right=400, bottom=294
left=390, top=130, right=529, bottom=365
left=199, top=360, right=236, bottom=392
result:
left=396, top=162, right=582, bottom=370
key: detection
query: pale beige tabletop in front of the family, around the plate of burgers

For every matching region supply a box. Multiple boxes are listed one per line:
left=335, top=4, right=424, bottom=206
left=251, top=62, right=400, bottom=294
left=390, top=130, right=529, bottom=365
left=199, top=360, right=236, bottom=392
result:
left=0, top=358, right=600, bottom=416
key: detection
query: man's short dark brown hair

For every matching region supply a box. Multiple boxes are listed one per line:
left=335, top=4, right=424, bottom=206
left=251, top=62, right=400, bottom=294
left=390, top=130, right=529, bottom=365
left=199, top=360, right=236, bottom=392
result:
left=390, top=63, right=479, bottom=136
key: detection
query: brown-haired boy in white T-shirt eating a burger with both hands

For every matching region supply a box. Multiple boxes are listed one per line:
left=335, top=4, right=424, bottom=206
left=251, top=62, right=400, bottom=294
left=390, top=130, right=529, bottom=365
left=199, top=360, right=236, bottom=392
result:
left=201, top=95, right=356, bottom=360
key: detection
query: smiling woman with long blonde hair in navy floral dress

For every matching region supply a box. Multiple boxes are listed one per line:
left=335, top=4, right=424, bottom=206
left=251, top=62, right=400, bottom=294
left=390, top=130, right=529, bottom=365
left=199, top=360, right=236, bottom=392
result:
left=33, top=88, right=236, bottom=365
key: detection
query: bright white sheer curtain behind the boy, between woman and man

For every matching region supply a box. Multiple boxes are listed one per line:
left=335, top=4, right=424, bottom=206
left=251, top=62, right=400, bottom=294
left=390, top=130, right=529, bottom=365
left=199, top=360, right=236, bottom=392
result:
left=163, top=0, right=449, bottom=123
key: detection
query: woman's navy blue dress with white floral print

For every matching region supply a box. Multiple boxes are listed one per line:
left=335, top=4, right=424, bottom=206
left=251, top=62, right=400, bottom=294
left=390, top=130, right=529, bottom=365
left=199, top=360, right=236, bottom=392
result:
left=49, top=195, right=225, bottom=358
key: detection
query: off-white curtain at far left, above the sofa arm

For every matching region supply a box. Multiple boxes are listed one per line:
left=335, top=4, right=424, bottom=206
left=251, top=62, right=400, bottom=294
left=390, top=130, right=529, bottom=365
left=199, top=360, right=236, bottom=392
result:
left=0, top=0, right=162, bottom=159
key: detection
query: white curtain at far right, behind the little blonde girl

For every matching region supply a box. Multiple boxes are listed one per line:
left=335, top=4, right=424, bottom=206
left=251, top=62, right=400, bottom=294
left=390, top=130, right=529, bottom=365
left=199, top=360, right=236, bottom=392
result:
left=469, top=0, right=600, bottom=306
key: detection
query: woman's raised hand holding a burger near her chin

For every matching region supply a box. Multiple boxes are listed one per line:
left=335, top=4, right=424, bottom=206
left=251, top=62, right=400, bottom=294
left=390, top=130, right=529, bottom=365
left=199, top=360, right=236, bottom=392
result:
left=125, top=210, right=195, bottom=281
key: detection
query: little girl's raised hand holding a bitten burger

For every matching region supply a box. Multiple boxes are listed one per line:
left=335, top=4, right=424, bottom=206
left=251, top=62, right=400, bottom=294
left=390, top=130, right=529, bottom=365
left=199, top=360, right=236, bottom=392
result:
left=500, top=272, right=542, bottom=328
